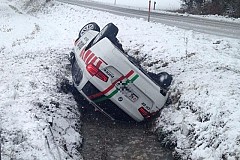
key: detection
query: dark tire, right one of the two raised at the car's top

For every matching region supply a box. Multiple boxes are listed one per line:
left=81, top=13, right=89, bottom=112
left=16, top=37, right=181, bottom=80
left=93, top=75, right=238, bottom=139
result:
left=89, top=23, right=118, bottom=48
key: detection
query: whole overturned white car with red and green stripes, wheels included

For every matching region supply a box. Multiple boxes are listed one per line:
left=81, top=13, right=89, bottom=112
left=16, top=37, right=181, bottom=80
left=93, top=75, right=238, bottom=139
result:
left=70, top=22, right=172, bottom=122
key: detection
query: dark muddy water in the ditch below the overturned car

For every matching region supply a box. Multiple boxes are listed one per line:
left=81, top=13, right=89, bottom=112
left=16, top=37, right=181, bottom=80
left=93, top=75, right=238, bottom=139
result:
left=79, top=103, right=173, bottom=160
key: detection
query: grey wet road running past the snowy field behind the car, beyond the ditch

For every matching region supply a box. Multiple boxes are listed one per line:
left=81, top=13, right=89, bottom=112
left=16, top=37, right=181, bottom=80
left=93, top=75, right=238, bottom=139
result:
left=58, top=0, right=240, bottom=39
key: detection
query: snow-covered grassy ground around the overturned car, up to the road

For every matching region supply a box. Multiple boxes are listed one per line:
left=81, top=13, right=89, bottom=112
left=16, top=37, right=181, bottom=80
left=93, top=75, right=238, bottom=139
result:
left=0, top=0, right=240, bottom=160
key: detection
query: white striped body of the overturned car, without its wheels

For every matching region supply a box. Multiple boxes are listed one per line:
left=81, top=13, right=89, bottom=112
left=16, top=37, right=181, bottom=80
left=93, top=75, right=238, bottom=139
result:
left=73, top=30, right=168, bottom=122
